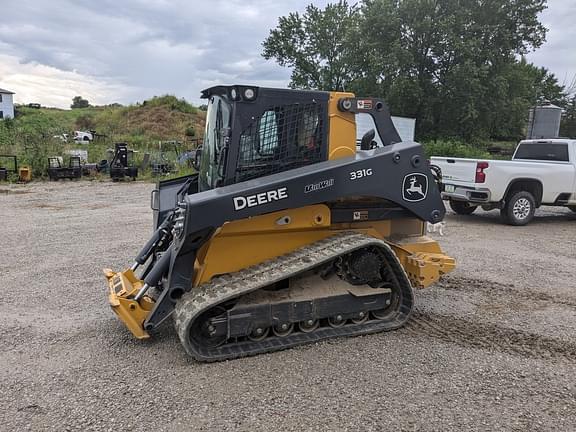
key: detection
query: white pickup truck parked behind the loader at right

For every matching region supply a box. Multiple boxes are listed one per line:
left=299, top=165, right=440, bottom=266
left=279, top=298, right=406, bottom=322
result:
left=431, top=138, right=576, bottom=225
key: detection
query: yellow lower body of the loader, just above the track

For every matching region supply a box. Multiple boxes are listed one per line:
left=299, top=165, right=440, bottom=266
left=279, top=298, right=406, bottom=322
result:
left=194, top=205, right=454, bottom=288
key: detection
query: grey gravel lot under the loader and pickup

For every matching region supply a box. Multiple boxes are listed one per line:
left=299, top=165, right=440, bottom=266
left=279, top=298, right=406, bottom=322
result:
left=0, top=182, right=576, bottom=431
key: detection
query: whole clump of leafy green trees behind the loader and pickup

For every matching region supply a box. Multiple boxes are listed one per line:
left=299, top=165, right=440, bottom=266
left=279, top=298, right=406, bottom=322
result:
left=263, top=0, right=563, bottom=140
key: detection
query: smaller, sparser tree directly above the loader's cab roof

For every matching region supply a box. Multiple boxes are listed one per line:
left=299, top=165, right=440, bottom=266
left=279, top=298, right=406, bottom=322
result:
left=262, top=0, right=359, bottom=90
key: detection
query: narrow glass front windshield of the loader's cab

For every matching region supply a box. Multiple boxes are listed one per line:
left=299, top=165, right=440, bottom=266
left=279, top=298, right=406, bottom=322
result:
left=198, top=96, right=231, bottom=191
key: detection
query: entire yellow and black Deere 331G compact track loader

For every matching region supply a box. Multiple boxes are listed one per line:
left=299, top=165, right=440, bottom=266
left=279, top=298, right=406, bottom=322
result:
left=105, top=86, right=454, bottom=361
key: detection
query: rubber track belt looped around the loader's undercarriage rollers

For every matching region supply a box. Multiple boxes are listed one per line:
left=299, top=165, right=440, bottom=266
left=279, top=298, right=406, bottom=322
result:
left=174, top=231, right=414, bottom=361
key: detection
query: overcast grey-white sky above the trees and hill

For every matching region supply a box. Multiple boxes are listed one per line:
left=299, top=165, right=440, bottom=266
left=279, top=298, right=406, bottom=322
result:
left=0, top=0, right=576, bottom=108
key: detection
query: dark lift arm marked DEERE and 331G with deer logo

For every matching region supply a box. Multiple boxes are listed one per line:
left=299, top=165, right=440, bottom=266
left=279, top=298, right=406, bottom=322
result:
left=168, top=142, right=445, bottom=290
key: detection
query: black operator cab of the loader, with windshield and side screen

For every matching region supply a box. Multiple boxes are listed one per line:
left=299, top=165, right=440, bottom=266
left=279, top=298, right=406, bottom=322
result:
left=198, top=86, right=330, bottom=191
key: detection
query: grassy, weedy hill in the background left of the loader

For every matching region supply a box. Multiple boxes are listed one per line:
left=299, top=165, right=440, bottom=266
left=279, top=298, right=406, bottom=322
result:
left=0, top=96, right=205, bottom=178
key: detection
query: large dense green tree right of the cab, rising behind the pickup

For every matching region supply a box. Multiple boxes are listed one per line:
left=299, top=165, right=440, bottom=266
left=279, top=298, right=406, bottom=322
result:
left=355, top=0, right=546, bottom=139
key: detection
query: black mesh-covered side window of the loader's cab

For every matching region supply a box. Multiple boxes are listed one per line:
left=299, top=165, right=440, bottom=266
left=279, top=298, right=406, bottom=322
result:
left=236, top=102, right=326, bottom=182
